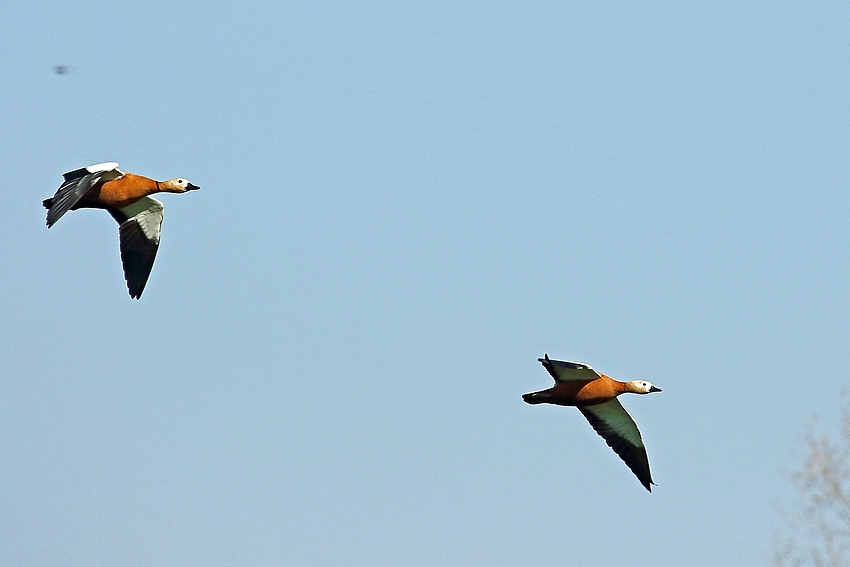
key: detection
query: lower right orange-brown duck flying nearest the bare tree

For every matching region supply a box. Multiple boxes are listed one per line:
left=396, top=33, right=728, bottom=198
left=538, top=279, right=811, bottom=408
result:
left=522, top=354, right=661, bottom=492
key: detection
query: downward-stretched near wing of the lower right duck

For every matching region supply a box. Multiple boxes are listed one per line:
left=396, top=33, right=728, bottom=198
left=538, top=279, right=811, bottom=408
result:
left=578, top=398, right=653, bottom=492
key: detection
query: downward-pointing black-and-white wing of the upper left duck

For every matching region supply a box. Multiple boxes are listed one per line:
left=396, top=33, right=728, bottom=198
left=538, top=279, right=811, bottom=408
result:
left=109, top=197, right=163, bottom=299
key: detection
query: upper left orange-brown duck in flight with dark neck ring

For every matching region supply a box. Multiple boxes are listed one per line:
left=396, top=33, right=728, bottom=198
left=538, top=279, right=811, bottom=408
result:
left=43, top=162, right=200, bottom=299
